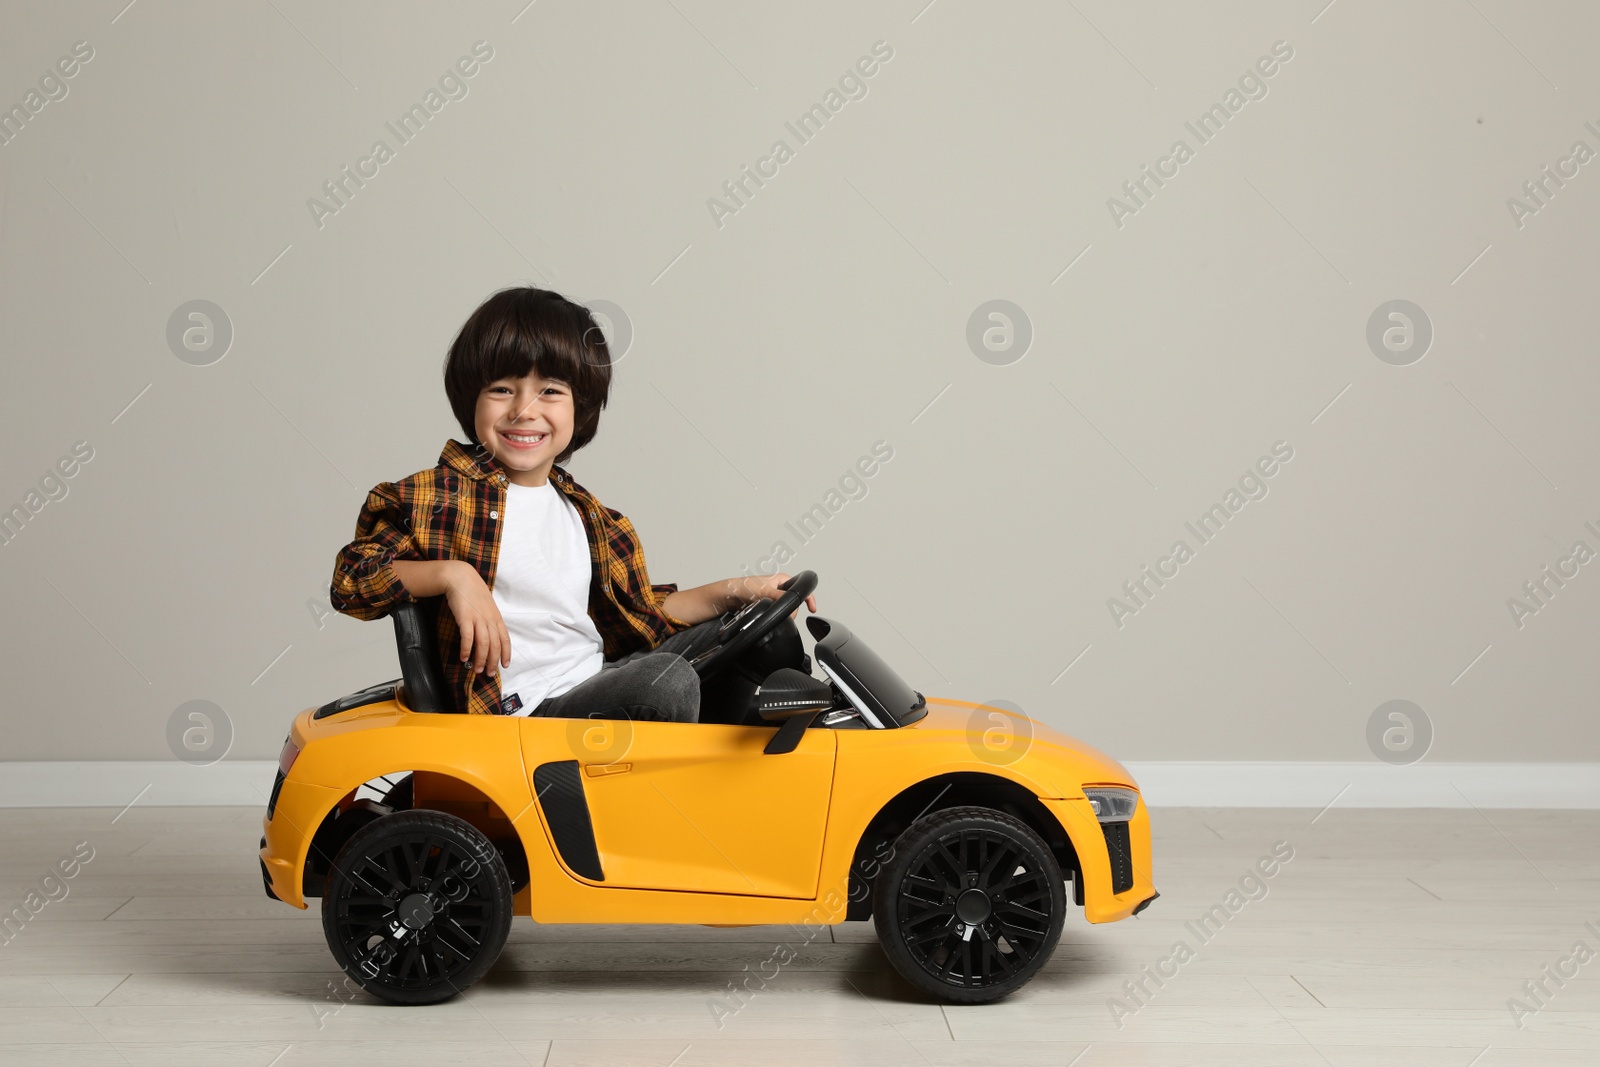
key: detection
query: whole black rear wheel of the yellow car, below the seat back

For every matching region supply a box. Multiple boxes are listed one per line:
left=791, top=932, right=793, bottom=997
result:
left=322, top=809, right=512, bottom=1005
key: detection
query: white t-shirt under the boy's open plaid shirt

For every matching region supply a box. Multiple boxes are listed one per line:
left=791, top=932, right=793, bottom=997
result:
left=493, top=480, right=605, bottom=715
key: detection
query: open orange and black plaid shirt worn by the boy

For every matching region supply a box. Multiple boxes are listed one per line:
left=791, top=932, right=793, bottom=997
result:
left=330, top=440, right=690, bottom=715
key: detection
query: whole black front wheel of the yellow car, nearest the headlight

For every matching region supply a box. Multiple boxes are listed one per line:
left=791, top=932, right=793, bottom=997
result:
left=872, top=808, right=1067, bottom=1005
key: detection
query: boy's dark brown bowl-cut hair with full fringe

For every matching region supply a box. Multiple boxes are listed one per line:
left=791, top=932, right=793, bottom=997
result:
left=445, top=286, right=611, bottom=462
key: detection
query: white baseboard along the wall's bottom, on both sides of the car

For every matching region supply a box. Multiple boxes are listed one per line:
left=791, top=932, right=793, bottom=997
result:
left=0, top=760, right=1600, bottom=809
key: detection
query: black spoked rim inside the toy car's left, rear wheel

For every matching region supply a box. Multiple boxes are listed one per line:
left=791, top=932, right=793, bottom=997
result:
left=334, top=832, right=496, bottom=992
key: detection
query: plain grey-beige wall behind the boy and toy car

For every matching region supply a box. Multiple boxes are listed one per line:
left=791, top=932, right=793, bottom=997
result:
left=0, top=0, right=1600, bottom=761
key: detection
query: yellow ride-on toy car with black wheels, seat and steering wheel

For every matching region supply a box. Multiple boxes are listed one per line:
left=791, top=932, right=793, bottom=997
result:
left=261, top=571, right=1157, bottom=1003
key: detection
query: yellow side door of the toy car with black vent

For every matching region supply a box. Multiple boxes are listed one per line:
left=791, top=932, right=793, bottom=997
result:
left=523, top=718, right=835, bottom=899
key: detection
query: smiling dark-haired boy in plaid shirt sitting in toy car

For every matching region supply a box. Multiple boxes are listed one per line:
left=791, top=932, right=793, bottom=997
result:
left=330, top=288, right=816, bottom=721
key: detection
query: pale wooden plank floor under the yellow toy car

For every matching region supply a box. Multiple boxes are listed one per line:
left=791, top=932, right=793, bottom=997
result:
left=0, top=806, right=1600, bottom=1067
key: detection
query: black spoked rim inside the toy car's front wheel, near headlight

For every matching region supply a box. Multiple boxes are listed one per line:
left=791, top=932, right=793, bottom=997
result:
left=896, top=829, right=1053, bottom=989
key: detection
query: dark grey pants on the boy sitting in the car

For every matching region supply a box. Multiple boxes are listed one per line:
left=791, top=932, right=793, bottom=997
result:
left=533, top=617, right=722, bottom=723
